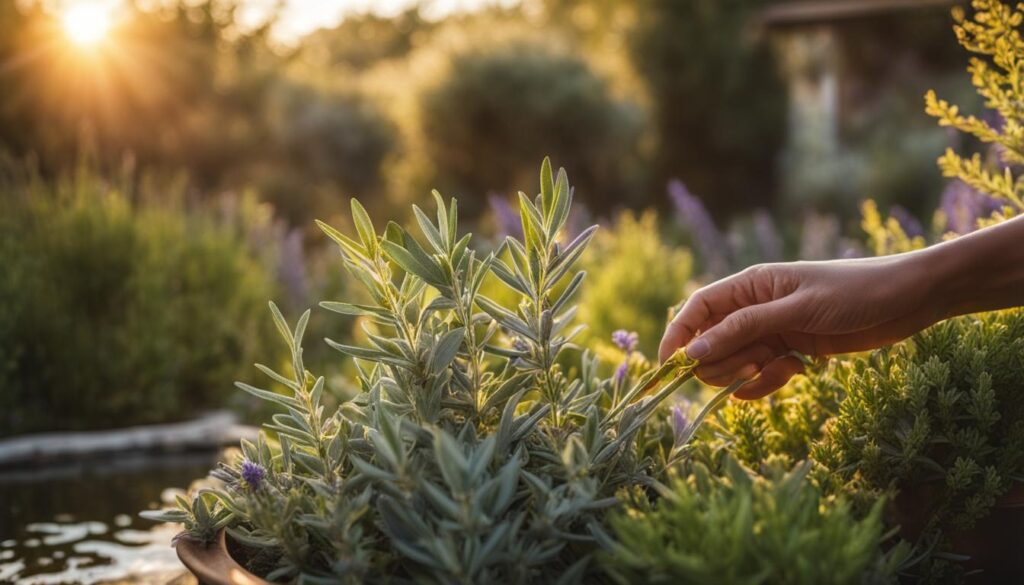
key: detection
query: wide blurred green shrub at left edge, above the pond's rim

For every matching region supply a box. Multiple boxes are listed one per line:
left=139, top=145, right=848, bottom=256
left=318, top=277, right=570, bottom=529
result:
left=0, top=166, right=273, bottom=434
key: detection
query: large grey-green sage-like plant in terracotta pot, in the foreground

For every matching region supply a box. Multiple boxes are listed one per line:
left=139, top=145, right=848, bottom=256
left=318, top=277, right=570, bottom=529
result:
left=148, top=160, right=734, bottom=583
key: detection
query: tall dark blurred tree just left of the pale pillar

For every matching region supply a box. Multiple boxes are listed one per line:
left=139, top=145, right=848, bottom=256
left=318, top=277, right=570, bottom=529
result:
left=630, top=0, right=785, bottom=214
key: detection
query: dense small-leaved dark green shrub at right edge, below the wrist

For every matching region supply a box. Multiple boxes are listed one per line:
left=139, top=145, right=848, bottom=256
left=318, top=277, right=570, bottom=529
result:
left=814, top=309, right=1024, bottom=533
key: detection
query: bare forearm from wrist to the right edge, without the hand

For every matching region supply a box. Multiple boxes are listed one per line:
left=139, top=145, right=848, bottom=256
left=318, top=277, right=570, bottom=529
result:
left=921, top=216, right=1024, bottom=319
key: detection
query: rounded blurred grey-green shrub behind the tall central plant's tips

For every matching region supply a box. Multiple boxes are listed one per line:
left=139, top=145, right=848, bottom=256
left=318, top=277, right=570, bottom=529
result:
left=419, top=41, right=640, bottom=214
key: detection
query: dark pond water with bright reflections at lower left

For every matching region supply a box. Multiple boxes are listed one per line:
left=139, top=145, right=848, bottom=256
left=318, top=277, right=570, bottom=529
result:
left=0, top=453, right=216, bottom=584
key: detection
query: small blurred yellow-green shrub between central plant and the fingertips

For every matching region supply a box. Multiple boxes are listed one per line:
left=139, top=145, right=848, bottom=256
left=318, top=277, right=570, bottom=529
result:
left=580, top=211, right=692, bottom=357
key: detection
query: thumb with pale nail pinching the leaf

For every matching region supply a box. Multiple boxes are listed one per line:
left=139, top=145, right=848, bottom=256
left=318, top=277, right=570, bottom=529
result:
left=686, top=299, right=795, bottom=363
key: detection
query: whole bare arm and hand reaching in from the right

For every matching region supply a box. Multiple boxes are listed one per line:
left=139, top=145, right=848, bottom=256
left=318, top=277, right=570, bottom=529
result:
left=659, top=213, right=1024, bottom=399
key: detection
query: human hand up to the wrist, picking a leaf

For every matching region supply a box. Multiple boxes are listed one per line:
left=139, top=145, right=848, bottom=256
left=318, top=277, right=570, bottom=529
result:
left=658, top=253, right=945, bottom=400
